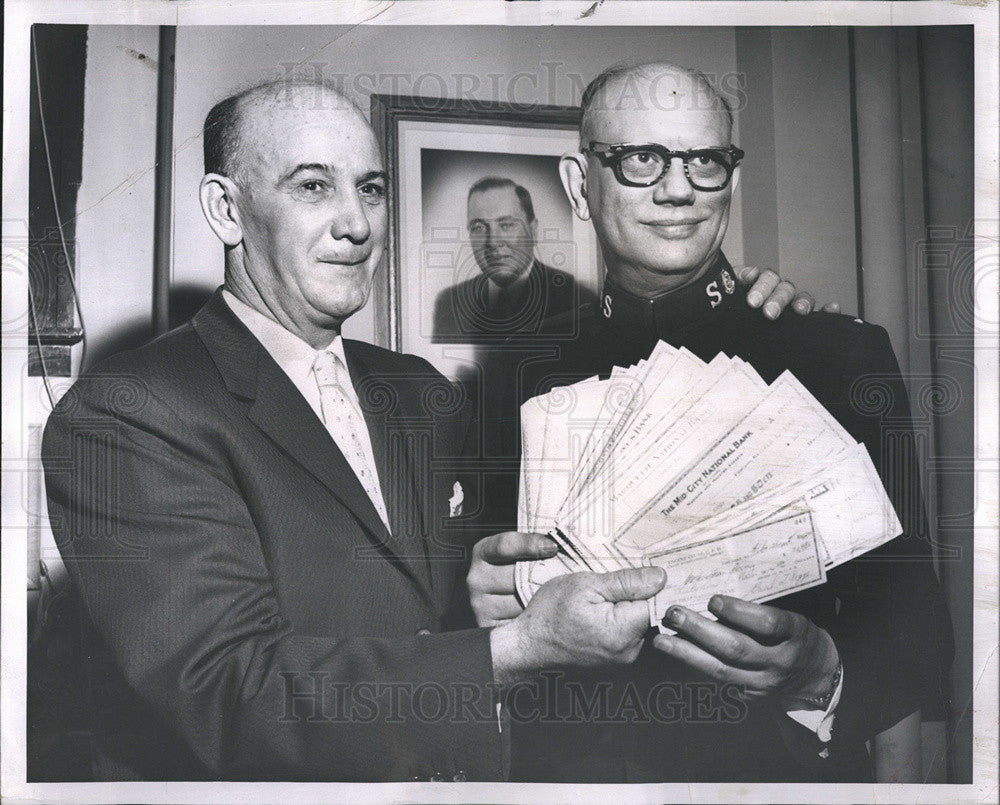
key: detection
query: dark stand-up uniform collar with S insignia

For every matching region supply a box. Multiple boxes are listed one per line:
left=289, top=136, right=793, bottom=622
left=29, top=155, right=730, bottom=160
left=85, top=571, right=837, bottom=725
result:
left=597, top=252, right=743, bottom=343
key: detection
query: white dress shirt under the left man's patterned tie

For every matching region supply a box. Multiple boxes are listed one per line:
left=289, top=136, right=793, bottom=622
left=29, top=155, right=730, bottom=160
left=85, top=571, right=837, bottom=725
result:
left=222, top=288, right=389, bottom=529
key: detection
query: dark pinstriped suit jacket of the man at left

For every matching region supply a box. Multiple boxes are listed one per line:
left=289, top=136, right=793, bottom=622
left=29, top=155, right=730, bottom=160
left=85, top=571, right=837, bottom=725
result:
left=43, top=293, right=506, bottom=780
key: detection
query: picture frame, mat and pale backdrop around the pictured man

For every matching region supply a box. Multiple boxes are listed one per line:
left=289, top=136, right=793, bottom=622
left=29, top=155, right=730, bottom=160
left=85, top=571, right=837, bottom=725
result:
left=371, top=94, right=603, bottom=379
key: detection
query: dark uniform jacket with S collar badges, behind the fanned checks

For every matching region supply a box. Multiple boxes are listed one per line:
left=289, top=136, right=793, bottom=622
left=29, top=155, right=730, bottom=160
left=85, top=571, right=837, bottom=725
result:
left=484, top=254, right=953, bottom=781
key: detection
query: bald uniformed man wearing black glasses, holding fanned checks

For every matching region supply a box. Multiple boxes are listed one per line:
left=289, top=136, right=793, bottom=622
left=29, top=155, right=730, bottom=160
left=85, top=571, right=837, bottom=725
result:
left=469, top=64, right=952, bottom=782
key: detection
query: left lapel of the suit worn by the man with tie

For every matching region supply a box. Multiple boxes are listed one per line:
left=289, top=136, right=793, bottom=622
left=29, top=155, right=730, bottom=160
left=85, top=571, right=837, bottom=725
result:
left=192, top=292, right=427, bottom=593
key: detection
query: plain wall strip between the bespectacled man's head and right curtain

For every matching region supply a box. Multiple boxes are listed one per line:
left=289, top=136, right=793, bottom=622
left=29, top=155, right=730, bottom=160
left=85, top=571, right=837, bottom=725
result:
left=736, top=27, right=858, bottom=314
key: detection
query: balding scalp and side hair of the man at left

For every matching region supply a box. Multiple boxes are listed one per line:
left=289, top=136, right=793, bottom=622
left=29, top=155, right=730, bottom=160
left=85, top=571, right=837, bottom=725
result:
left=203, top=79, right=367, bottom=182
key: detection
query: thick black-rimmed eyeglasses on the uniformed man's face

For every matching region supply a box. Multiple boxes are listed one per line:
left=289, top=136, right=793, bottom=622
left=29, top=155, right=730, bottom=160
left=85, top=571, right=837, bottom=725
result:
left=585, top=142, right=744, bottom=190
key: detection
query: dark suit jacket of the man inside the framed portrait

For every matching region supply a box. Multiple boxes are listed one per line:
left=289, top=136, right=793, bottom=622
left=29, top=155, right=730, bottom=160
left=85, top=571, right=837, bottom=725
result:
left=432, top=260, right=595, bottom=344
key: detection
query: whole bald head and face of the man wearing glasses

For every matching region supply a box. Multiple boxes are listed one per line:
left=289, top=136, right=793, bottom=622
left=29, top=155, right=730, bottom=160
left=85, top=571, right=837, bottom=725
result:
left=559, top=63, right=739, bottom=297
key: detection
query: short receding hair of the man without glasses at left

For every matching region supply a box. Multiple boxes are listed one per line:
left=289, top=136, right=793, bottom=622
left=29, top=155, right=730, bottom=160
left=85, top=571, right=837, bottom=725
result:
left=202, top=78, right=363, bottom=180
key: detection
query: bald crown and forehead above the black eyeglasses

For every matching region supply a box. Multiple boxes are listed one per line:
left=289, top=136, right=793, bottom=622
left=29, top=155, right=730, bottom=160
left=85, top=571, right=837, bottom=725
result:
left=580, top=62, right=733, bottom=146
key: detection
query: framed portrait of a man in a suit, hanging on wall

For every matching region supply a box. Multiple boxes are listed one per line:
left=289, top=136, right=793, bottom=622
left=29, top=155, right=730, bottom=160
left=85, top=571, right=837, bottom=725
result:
left=371, top=95, right=602, bottom=378
